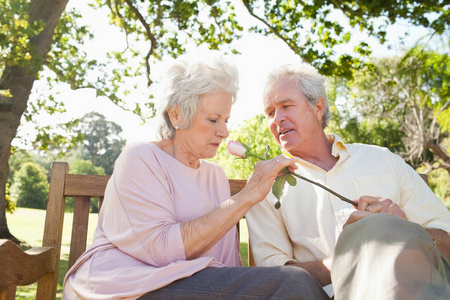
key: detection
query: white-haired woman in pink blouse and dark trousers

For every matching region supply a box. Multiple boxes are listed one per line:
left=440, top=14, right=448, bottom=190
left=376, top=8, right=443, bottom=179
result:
left=64, top=56, right=328, bottom=299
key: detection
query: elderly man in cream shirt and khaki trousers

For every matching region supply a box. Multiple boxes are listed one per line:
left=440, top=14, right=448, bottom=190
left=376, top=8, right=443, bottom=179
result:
left=246, top=64, right=450, bottom=299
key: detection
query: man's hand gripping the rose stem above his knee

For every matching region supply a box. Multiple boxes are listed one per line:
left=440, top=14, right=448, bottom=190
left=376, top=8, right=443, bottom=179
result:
left=344, top=196, right=407, bottom=227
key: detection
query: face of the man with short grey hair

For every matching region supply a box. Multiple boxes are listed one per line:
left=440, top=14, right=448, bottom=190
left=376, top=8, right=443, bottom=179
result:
left=263, top=78, right=323, bottom=157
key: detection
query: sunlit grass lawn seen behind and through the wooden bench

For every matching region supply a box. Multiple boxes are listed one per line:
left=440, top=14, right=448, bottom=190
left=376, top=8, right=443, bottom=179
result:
left=6, top=208, right=248, bottom=300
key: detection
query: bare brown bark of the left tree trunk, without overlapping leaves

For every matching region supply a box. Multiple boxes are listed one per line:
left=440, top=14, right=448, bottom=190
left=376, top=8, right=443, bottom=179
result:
left=0, top=0, right=68, bottom=242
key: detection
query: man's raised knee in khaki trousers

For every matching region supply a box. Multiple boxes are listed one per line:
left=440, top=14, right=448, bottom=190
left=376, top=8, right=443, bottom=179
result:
left=332, top=213, right=448, bottom=299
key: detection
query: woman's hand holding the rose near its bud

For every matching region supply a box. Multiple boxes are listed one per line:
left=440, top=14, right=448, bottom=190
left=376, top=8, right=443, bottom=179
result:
left=239, top=155, right=298, bottom=205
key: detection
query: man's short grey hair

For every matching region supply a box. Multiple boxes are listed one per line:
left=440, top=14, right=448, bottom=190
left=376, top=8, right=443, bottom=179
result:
left=266, top=63, right=331, bottom=128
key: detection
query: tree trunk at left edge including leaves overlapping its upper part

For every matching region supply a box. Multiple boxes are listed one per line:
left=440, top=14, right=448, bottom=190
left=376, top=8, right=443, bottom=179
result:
left=0, top=0, right=68, bottom=243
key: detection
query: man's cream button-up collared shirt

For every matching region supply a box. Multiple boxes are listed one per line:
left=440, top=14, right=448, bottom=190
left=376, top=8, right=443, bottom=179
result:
left=246, top=134, right=450, bottom=266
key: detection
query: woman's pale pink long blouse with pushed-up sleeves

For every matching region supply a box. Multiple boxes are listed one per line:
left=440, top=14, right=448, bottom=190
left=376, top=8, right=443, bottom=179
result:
left=63, top=143, right=239, bottom=299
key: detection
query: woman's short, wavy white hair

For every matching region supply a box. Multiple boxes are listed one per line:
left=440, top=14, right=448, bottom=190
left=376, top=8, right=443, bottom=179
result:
left=158, top=55, right=239, bottom=139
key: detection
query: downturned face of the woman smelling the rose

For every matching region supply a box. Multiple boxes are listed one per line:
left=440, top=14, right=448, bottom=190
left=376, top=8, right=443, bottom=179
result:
left=175, top=92, right=233, bottom=161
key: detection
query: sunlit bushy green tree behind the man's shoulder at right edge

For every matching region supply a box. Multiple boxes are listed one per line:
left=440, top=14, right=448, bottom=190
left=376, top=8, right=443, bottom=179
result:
left=342, top=46, right=450, bottom=173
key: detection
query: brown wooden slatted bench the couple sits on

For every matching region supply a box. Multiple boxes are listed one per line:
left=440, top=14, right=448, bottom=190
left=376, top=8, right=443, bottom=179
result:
left=0, top=162, right=250, bottom=300
